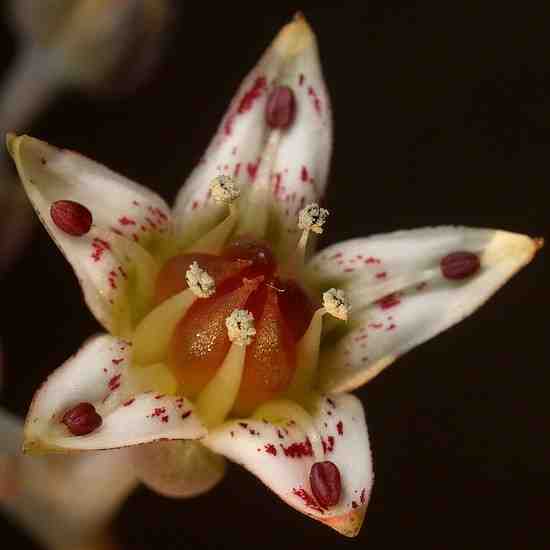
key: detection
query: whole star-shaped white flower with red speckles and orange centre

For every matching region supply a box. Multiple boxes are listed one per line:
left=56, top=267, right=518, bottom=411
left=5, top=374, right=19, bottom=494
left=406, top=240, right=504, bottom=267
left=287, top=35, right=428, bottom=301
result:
left=8, top=17, right=538, bottom=536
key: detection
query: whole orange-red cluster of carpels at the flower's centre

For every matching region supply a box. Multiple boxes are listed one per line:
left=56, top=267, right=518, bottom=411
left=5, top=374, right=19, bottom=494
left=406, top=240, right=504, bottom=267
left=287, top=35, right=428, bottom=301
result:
left=156, top=238, right=315, bottom=416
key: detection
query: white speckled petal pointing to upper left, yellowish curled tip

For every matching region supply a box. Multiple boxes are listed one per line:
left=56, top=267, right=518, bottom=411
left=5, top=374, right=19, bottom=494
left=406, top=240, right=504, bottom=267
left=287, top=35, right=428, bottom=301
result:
left=8, top=136, right=170, bottom=334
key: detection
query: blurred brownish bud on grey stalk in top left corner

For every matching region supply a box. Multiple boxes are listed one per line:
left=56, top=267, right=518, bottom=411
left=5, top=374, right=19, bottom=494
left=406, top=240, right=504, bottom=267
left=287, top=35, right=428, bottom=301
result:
left=0, top=0, right=174, bottom=135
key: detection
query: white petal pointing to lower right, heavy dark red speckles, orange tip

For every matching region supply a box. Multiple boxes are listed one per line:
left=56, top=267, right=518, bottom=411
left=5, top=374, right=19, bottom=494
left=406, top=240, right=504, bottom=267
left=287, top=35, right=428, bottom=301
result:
left=203, top=395, right=374, bottom=537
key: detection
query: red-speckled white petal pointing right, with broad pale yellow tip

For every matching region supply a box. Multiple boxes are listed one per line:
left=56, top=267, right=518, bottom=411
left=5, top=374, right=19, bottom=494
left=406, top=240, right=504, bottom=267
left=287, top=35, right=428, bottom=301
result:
left=308, top=227, right=542, bottom=391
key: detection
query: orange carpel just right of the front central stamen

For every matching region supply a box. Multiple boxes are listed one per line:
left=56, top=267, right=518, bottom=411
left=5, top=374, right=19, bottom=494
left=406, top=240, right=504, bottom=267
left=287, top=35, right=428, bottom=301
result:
left=233, top=286, right=296, bottom=416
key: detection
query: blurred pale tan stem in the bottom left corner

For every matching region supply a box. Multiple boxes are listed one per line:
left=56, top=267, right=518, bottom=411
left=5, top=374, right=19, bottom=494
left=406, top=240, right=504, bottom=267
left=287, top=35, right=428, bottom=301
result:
left=0, top=410, right=137, bottom=550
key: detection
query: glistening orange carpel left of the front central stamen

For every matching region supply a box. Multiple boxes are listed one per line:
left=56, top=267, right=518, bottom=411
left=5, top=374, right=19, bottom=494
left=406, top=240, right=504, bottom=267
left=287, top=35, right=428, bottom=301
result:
left=168, top=276, right=264, bottom=398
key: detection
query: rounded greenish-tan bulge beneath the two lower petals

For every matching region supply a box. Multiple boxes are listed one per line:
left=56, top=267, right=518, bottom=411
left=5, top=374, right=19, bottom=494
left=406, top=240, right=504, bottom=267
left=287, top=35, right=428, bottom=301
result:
left=130, top=441, right=225, bottom=498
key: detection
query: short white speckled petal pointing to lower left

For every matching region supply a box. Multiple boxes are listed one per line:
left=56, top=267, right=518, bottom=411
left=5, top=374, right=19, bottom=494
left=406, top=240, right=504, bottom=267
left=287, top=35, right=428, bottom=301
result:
left=24, top=335, right=206, bottom=452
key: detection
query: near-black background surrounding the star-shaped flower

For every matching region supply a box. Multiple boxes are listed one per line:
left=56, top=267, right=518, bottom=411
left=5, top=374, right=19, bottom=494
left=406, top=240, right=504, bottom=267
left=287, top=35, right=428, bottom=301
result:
left=0, top=4, right=550, bottom=550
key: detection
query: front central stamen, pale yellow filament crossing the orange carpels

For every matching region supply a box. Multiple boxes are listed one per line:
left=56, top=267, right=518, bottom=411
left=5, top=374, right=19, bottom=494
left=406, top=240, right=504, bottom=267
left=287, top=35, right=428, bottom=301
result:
left=197, top=309, right=256, bottom=428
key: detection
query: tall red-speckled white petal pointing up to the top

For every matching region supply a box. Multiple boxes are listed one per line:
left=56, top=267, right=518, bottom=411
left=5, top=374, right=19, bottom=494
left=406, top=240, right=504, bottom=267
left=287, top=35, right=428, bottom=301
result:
left=176, top=16, right=332, bottom=252
